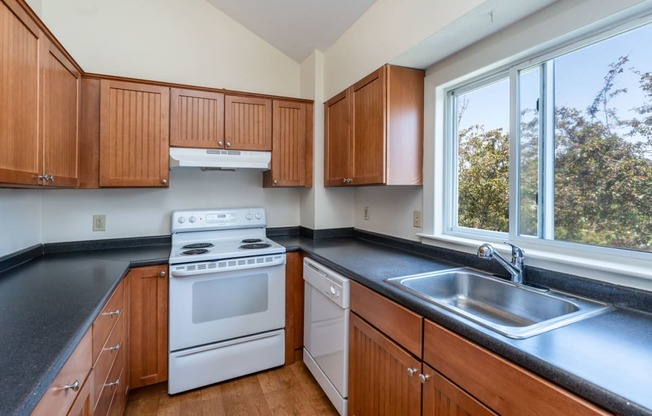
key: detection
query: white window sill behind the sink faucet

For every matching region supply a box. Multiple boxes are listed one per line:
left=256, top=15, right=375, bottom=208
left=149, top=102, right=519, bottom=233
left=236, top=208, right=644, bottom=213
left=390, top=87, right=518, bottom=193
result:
left=417, top=233, right=652, bottom=291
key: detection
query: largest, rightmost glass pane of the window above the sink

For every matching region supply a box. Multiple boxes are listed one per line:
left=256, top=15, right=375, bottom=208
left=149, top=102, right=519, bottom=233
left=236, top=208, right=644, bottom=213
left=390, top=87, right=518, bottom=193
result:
left=554, top=25, right=652, bottom=251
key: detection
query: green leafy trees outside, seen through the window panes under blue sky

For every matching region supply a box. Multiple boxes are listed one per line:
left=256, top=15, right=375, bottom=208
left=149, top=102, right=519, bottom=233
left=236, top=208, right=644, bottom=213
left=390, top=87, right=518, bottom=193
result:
left=458, top=56, right=652, bottom=251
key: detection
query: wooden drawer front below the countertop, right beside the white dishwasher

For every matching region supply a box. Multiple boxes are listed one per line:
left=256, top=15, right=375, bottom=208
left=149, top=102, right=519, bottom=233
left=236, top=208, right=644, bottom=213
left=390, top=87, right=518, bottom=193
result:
left=351, top=282, right=423, bottom=357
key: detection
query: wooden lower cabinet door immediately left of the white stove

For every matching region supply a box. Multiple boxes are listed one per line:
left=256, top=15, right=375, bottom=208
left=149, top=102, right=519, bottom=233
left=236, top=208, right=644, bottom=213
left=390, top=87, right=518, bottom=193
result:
left=127, top=266, right=168, bottom=388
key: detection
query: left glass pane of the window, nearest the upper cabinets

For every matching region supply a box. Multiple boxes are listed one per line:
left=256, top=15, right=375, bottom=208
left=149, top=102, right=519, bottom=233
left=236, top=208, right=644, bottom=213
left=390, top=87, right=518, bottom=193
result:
left=453, top=78, right=509, bottom=232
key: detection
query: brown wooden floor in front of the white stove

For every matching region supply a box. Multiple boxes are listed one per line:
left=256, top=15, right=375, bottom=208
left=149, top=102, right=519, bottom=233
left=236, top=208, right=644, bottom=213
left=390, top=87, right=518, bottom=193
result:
left=125, top=361, right=337, bottom=416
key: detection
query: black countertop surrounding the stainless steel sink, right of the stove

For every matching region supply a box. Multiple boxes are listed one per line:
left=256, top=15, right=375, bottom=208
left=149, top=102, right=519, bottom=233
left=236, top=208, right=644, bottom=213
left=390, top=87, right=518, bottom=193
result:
left=273, top=237, right=652, bottom=416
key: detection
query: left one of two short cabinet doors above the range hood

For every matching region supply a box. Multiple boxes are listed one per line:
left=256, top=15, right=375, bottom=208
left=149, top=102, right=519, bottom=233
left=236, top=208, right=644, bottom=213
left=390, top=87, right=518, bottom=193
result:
left=170, top=88, right=224, bottom=149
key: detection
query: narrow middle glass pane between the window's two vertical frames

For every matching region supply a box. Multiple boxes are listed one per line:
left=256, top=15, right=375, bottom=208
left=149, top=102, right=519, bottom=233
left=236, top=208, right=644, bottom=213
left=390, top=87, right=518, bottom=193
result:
left=519, top=67, right=542, bottom=236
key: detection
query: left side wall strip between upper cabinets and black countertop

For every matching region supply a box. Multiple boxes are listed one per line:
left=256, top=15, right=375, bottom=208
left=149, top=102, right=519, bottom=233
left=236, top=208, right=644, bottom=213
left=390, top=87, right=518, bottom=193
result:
left=0, top=189, right=41, bottom=257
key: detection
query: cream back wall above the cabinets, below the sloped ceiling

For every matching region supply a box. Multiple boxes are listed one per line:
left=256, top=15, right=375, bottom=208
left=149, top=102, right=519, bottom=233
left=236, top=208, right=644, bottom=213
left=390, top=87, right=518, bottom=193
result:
left=41, top=0, right=299, bottom=97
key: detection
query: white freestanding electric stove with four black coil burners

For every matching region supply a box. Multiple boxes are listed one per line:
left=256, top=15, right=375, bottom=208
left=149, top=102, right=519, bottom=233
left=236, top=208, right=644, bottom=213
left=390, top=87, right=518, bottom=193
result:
left=168, top=208, right=285, bottom=394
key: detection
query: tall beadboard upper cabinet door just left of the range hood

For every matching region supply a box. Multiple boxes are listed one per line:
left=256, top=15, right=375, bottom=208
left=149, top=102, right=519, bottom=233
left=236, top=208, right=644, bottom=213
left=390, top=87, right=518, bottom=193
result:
left=100, top=79, right=170, bottom=187
